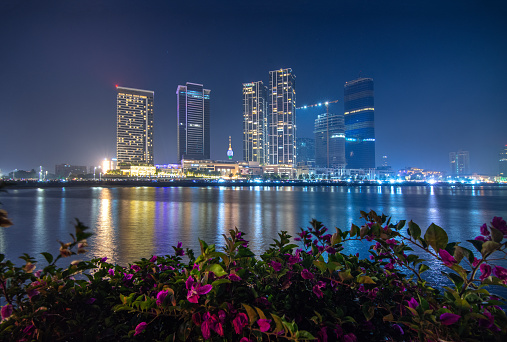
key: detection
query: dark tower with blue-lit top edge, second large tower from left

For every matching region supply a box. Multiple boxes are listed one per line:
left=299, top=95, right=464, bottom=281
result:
left=176, top=82, right=211, bottom=161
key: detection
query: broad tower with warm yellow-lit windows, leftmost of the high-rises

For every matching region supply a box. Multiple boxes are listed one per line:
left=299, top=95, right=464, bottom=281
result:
left=116, top=86, right=154, bottom=165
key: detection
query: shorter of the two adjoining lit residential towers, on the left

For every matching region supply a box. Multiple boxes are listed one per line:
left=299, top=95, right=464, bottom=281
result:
left=243, top=81, right=268, bottom=164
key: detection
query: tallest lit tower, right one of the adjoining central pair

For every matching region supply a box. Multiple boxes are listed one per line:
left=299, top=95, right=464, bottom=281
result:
left=268, top=68, right=296, bottom=165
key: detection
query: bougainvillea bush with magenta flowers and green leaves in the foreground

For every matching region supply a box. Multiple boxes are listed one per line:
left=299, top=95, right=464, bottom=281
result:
left=0, top=211, right=507, bottom=342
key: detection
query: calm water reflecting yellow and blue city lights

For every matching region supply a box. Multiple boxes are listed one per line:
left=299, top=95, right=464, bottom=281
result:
left=0, top=186, right=507, bottom=278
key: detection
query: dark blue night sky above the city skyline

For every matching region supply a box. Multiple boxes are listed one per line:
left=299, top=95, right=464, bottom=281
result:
left=0, top=0, right=507, bottom=175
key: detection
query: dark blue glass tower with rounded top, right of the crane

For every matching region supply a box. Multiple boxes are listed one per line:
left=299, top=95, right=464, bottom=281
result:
left=344, top=78, right=375, bottom=169
